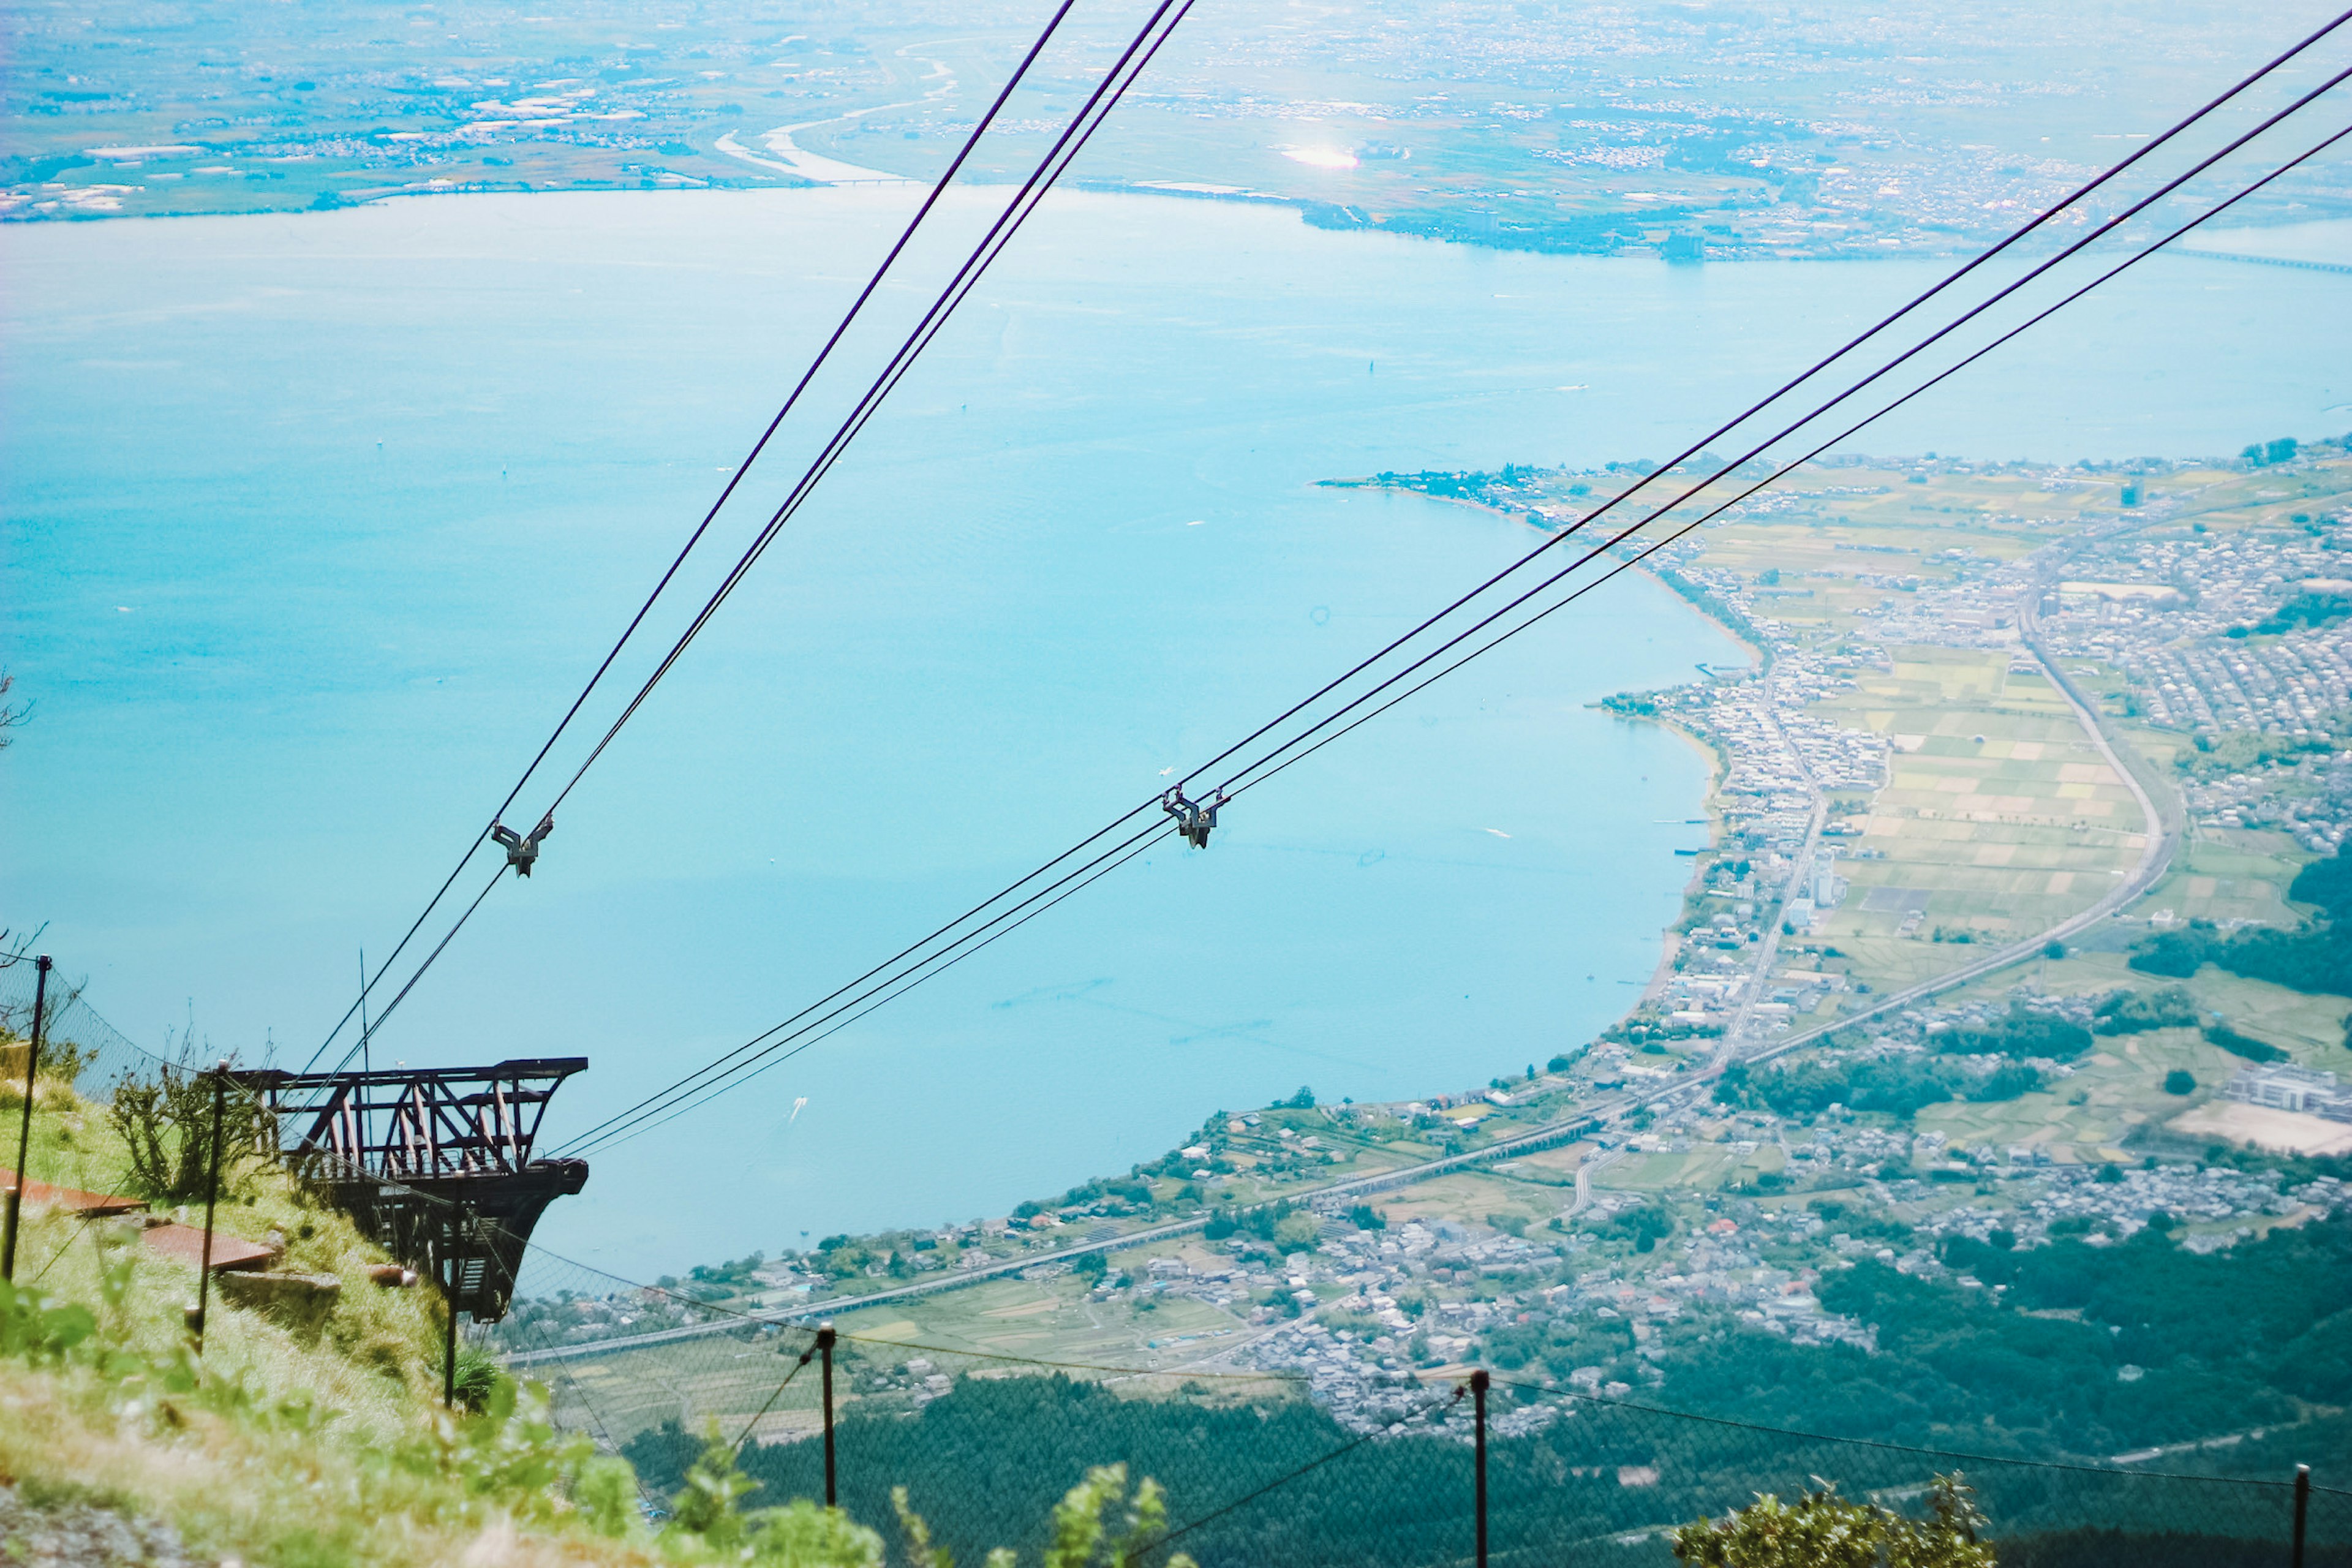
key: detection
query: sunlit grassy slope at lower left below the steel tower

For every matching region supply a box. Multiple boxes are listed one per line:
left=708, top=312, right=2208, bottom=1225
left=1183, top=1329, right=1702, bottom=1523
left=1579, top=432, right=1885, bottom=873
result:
left=0, top=1084, right=654, bottom=1563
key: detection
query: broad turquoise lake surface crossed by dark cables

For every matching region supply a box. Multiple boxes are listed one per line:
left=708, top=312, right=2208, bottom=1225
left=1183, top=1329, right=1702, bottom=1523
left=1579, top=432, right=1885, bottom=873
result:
left=0, top=190, right=2352, bottom=1276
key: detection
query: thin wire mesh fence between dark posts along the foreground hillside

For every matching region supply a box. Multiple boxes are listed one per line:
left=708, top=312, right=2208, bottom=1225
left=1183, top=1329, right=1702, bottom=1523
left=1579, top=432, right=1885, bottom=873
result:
left=0, top=964, right=2352, bottom=1568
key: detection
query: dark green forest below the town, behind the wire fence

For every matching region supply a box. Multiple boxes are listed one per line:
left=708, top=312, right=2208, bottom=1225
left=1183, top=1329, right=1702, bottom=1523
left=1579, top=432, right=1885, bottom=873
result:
left=625, top=1218, right=2352, bottom=1568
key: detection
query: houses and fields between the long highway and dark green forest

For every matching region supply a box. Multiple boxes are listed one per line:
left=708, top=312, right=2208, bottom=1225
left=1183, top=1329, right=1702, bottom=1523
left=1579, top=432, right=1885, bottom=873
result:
left=508, top=1048, right=2352, bottom=1441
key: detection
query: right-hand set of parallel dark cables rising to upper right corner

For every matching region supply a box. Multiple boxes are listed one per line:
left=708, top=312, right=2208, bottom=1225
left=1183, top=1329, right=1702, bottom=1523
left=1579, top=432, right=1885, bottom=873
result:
left=541, top=12, right=2352, bottom=1154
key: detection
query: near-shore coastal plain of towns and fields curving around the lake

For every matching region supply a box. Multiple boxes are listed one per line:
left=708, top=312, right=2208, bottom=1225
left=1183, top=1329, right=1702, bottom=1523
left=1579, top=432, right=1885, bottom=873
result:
left=503, top=442, right=2352, bottom=1466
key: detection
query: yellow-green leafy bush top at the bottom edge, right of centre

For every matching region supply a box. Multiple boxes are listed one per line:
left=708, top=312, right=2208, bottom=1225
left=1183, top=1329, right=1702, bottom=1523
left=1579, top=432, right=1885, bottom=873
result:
left=1672, top=1474, right=1994, bottom=1568
